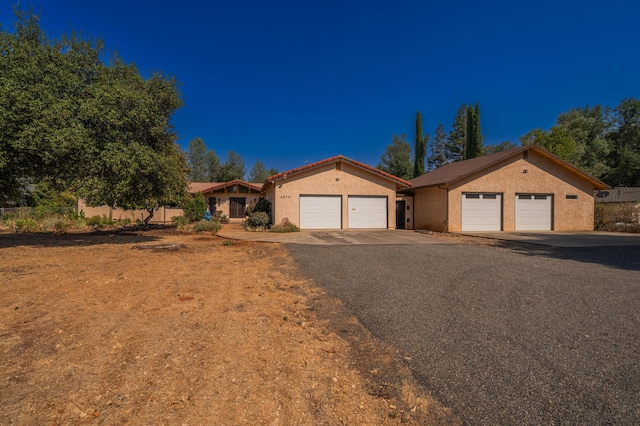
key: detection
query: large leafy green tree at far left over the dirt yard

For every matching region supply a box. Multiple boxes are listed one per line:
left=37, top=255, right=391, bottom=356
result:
left=0, top=9, right=187, bottom=223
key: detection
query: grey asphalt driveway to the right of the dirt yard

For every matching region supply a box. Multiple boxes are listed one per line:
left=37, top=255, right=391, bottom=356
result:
left=289, top=244, right=640, bottom=425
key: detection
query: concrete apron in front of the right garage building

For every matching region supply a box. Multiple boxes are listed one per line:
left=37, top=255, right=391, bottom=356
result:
left=459, top=231, right=640, bottom=247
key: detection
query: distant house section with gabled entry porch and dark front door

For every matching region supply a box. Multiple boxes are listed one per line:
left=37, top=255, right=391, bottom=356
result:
left=189, top=180, right=263, bottom=219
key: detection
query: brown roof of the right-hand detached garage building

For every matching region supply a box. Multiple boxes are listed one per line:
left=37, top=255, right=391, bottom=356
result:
left=411, top=145, right=609, bottom=189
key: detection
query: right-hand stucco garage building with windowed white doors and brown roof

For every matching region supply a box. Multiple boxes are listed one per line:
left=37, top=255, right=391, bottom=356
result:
left=401, top=145, right=609, bottom=232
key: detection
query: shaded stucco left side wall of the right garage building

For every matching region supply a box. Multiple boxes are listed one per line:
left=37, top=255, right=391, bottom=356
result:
left=414, top=187, right=447, bottom=232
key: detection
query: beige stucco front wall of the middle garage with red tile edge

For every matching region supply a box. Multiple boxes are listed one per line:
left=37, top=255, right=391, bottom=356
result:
left=266, top=162, right=396, bottom=229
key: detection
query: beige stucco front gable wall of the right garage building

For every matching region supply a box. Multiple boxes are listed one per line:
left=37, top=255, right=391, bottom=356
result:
left=442, top=151, right=594, bottom=232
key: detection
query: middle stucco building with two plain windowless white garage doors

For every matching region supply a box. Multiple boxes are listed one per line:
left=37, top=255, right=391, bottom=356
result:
left=261, top=155, right=413, bottom=229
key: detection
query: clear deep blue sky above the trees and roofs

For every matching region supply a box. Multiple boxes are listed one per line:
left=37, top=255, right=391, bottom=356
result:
left=0, top=0, right=640, bottom=172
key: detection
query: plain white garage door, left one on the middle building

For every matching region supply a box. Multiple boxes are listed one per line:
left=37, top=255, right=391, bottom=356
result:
left=300, top=195, right=342, bottom=229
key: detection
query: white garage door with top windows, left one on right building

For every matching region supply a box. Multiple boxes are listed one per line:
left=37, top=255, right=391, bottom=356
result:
left=462, top=193, right=502, bottom=231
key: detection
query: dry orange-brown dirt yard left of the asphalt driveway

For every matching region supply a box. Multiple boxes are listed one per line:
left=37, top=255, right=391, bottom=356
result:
left=0, top=229, right=459, bottom=425
